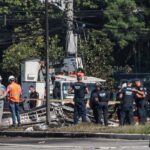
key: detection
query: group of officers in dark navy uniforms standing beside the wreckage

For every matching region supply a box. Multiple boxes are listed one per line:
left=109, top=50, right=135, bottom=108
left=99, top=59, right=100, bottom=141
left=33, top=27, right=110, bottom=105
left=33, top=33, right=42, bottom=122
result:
left=68, top=77, right=147, bottom=126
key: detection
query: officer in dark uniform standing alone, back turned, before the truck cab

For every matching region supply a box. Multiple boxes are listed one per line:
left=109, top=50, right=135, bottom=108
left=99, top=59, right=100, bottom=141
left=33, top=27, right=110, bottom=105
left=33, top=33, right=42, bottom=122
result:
left=68, top=76, right=89, bottom=124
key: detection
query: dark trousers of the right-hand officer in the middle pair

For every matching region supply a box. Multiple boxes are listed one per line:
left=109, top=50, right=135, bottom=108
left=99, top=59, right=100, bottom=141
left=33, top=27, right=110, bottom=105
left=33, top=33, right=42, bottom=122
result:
left=98, top=102, right=108, bottom=126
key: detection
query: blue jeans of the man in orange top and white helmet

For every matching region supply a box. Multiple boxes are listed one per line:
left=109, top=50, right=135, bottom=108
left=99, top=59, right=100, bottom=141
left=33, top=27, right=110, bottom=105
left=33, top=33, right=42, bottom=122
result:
left=9, top=102, right=20, bottom=126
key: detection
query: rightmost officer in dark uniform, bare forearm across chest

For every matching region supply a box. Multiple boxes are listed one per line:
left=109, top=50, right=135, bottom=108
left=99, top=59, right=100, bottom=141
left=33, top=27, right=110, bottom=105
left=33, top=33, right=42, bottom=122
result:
left=134, top=80, right=147, bottom=125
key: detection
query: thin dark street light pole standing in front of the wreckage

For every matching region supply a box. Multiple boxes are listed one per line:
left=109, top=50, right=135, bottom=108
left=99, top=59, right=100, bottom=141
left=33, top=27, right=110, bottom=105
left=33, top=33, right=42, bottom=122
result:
left=45, top=0, right=50, bottom=125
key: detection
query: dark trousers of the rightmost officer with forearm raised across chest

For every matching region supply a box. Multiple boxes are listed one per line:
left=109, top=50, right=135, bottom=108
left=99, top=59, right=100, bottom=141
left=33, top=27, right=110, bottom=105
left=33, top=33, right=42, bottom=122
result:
left=137, top=100, right=146, bottom=124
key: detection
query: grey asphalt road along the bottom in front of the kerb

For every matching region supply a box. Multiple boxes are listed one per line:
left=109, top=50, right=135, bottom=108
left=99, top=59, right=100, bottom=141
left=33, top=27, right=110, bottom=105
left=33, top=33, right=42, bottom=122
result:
left=0, top=137, right=150, bottom=150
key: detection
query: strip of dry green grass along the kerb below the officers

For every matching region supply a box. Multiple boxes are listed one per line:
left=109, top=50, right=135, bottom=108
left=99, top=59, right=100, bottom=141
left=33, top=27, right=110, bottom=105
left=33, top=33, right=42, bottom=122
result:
left=49, top=123, right=150, bottom=134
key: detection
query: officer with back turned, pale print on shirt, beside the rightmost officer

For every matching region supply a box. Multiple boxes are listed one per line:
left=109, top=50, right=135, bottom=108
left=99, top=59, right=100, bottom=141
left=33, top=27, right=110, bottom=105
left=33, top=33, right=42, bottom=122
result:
left=120, top=81, right=134, bottom=126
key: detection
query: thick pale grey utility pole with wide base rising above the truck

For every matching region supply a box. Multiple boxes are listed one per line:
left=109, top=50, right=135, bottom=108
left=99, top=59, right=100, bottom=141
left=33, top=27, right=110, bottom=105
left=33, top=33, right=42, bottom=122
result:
left=61, top=0, right=83, bottom=72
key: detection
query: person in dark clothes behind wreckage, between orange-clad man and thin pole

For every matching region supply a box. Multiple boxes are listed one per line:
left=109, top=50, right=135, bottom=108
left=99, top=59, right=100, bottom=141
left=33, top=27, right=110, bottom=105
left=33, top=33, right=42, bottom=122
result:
left=29, top=85, right=39, bottom=109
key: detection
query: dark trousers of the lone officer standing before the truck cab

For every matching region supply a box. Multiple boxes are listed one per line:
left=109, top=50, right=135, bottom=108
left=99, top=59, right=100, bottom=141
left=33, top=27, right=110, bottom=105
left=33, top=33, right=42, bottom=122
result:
left=74, top=99, right=87, bottom=124
